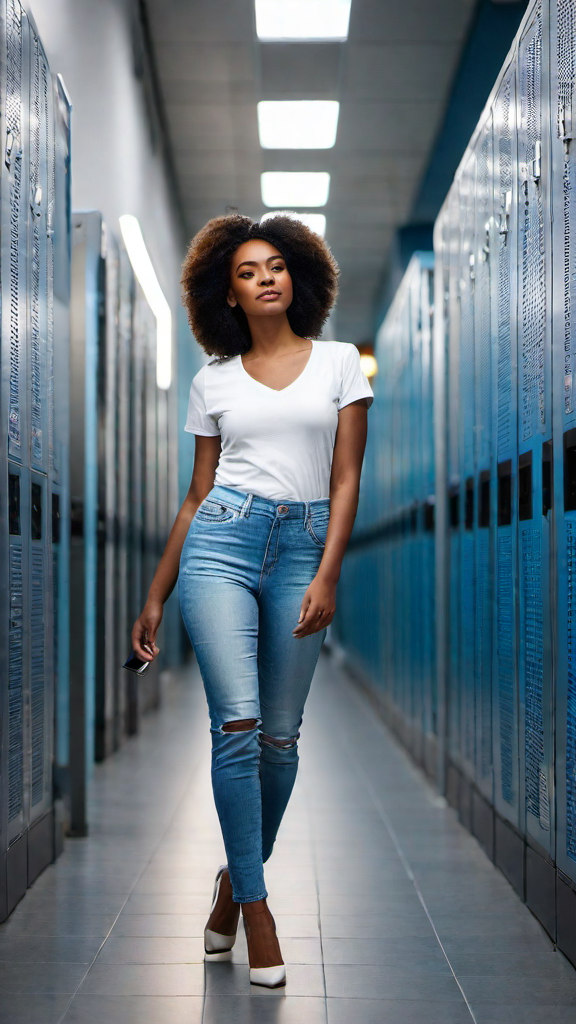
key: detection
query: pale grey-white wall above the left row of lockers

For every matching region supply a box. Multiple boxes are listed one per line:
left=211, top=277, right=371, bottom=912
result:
left=28, top=0, right=183, bottom=303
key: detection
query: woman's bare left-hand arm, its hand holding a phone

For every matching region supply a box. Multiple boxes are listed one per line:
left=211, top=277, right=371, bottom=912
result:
left=132, top=434, right=220, bottom=662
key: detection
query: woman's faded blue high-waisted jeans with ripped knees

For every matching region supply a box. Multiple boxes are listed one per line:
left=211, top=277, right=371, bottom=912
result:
left=178, top=486, right=330, bottom=903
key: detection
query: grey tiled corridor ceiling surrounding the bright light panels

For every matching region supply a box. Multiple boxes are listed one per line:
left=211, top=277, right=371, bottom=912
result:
left=142, top=0, right=475, bottom=343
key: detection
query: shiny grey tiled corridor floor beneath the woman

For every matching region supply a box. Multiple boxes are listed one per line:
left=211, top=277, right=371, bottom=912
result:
left=0, top=658, right=576, bottom=1024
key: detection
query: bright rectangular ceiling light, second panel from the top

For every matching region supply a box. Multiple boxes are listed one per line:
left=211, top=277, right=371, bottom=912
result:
left=258, top=99, right=340, bottom=150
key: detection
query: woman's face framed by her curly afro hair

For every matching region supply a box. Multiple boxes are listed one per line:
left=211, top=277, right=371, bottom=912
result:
left=228, top=239, right=293, bottom=316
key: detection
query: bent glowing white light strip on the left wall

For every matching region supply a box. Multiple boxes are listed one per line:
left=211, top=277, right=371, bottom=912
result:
left=120, top=213, right=172, bottom=391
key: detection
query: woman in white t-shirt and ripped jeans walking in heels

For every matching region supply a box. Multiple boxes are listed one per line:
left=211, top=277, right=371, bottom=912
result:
left=132, top=215, right=372, bottom=987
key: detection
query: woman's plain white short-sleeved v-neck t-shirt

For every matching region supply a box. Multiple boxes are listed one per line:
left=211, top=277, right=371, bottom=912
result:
left=186, top=341, right=372, bottom=502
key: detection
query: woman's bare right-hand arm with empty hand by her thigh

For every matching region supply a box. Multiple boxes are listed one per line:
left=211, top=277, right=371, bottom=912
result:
left=293, top=398, right=368, bottom=637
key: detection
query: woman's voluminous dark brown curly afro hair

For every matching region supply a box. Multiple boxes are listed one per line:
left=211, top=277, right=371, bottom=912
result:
left=181, top=213, right=339, bottom=358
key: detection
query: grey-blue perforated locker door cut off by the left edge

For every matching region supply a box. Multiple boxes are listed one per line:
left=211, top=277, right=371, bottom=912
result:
left=0, top=0, right=30, bottom=914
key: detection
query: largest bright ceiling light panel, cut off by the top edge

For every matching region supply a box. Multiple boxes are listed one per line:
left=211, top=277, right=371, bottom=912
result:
left=255, top=0, right=352, bottom=41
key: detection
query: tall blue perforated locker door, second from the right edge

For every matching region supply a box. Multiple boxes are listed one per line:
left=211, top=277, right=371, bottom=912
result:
left=517, top=4, right=553, bottom=854
